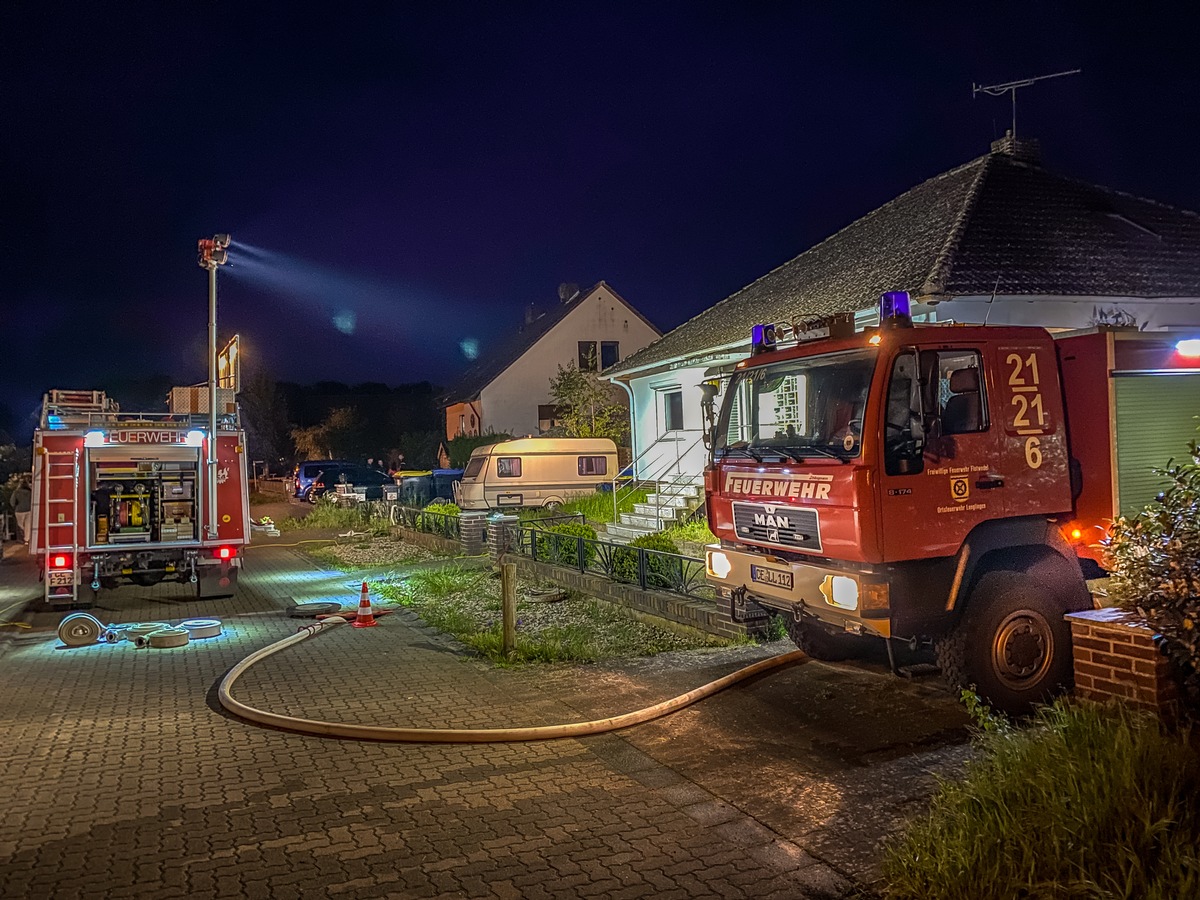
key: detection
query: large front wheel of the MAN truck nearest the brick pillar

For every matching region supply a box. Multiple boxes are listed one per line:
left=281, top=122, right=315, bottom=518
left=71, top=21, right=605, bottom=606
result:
left=937, top=570, right=1073, bottom=715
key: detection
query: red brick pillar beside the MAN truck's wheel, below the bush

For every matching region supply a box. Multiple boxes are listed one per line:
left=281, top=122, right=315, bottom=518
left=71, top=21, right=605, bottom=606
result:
left=1067, top=608, right=1181, bottom=722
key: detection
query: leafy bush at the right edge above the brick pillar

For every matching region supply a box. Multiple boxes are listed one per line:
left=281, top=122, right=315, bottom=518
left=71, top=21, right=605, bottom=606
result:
left=1106, top=440, right=1200, bottom=713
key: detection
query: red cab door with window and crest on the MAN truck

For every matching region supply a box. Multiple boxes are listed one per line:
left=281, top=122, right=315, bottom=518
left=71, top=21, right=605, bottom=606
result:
left=880, top=347, right=1007, bottom=560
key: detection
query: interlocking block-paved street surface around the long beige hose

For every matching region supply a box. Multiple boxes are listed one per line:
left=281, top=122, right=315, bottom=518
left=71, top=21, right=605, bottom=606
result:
left=0, top=532, right=965, bottom=900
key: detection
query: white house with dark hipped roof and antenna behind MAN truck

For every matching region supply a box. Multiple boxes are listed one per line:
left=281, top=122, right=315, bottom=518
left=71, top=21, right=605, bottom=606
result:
left=605, top=138, right=1200, bottom=480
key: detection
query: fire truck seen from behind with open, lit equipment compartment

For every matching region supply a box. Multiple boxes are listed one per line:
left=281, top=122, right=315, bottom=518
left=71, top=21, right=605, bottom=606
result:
left=30, top=389, right=250, bottom=608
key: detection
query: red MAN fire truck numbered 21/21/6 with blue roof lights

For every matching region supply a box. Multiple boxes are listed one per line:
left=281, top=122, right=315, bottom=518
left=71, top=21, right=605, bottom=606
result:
left=704, top=292, right=1200, bottom=713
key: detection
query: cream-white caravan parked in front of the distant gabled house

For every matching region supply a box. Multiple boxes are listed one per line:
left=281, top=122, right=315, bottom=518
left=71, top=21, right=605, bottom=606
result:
left=454, top=438, right=617, bottom=509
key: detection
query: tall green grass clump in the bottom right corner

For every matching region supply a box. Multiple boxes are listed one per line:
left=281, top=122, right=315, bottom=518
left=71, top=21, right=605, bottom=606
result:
left=883, top=701, right=1200, bottom=900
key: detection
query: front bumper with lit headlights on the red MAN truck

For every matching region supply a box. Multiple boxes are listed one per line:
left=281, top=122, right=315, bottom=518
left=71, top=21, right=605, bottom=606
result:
left=704, top=544, right=892, bottom=637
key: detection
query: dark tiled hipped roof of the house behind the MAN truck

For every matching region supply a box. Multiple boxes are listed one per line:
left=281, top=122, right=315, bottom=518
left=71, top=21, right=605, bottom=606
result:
left=605, top=138, right=1200, bottom=376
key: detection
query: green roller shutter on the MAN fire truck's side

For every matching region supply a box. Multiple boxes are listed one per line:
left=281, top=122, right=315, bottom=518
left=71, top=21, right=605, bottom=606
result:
left=1112, top=374, right=1200, bottom=516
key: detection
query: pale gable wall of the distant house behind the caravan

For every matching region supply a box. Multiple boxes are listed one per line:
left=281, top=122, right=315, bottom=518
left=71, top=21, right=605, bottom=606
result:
left=480, top=286, right=659, bottom=437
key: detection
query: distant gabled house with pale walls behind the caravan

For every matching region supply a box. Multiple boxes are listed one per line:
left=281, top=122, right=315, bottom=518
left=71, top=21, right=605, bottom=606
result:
left=442, top=281, right=662, bottom=440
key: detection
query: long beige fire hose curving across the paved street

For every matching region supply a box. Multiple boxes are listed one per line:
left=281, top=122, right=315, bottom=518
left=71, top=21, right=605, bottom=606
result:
left=217, top=617, right=809, bottom=744
